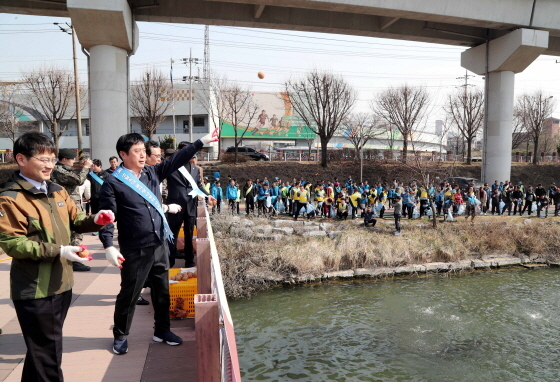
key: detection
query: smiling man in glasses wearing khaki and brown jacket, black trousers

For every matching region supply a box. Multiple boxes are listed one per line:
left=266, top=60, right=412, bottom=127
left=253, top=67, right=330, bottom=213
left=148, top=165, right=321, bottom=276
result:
left=0, top=132, right=112, bottom=381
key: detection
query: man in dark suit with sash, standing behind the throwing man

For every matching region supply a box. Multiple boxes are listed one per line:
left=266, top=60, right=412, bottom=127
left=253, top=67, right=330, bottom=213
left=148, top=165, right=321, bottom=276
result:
left=167, top=141, right=212, bottom=267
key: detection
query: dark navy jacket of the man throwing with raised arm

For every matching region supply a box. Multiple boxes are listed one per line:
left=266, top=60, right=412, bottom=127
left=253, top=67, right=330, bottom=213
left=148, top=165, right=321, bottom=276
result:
left=99, top=140, right=203, bottom=251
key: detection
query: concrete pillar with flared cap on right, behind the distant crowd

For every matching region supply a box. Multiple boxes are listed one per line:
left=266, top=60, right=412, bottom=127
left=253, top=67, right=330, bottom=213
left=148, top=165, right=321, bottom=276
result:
left=461, top=29, right=548, bottom=183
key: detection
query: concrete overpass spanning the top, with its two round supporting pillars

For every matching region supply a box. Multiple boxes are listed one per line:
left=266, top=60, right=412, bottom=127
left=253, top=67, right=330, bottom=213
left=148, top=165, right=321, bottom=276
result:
left=0, top=0, right=560, bottom=181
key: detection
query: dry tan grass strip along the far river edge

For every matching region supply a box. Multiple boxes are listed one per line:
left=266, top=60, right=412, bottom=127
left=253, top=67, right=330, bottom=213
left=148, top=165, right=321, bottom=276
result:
left=212, top=215, right=560, bottom=298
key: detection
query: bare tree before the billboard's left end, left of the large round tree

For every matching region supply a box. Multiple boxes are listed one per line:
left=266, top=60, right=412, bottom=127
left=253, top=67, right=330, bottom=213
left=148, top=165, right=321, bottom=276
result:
left=219, top=81, right=264, bottom=163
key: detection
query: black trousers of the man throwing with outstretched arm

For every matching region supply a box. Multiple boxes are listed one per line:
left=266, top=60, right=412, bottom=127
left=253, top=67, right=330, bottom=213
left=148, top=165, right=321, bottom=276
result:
left=113, top=243, right=170, bottom=340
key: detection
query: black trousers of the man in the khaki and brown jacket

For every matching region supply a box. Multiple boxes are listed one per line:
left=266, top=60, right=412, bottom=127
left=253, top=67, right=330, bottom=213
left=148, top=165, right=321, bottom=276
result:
left=14, top=290, right=72, bottom=382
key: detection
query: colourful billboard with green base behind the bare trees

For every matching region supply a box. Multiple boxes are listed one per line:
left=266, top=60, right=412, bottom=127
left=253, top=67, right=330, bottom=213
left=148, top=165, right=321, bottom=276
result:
left=220, top=92, right=315, bottom=139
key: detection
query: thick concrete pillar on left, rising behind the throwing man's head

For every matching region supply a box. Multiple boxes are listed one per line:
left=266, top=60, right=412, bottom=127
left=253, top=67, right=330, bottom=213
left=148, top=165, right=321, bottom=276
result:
left=67, top=0, right=138, bottom=166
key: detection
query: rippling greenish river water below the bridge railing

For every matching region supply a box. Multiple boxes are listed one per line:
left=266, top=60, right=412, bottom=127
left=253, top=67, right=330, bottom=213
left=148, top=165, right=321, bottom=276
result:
left=230, top=269, right=560, bottom=382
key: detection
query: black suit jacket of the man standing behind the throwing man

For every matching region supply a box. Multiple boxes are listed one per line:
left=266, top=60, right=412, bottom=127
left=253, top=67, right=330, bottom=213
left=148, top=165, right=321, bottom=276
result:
left=167, top=163, right=210, bottom=217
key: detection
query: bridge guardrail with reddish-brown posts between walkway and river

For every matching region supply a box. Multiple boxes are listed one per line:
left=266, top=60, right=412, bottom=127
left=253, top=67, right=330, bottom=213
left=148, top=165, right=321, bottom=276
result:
left=194, top=200, right=241, bottom=382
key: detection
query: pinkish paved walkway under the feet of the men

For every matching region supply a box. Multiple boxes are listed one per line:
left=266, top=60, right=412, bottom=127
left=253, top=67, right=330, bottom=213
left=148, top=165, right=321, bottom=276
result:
left=0, top=235, right=197, bottom=382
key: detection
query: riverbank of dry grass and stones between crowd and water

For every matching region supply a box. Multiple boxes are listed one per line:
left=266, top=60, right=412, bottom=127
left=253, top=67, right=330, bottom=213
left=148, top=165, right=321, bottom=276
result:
left=212, top=211, right=560, bottom=298
